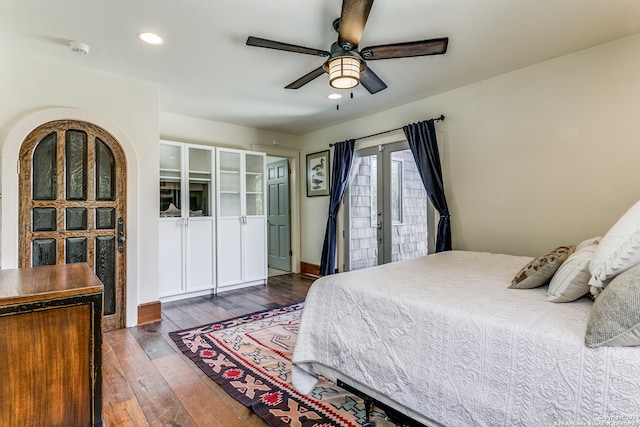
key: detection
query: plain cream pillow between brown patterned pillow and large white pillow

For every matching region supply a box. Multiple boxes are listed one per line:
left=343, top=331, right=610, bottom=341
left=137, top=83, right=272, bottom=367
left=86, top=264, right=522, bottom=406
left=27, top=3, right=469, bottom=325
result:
left=547, top=237, right=601, bottom=302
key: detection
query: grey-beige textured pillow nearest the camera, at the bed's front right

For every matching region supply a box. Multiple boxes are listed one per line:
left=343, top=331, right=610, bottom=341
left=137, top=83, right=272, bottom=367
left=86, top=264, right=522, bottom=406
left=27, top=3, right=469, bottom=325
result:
left=585, top=266, right=640, bottom=347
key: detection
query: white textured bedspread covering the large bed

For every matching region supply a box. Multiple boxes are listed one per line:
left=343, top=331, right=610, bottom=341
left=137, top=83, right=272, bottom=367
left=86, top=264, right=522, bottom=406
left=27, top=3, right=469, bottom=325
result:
left=293, top=251, right=640, bottom=427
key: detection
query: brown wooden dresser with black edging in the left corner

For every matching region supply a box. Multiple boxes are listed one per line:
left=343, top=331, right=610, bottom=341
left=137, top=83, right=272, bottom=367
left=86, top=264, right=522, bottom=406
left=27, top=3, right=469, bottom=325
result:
left=0, top=263, right=102, bottom=427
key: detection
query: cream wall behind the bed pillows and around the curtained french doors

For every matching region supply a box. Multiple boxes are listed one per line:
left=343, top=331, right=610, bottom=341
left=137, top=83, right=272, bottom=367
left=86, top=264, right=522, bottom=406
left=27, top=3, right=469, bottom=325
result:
left=301, top=35, right=640, bottom=264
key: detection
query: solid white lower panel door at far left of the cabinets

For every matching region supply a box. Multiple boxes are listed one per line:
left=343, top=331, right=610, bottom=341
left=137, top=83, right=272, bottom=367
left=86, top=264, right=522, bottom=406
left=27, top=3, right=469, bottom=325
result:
left=158, top=218, right=184, bottom=297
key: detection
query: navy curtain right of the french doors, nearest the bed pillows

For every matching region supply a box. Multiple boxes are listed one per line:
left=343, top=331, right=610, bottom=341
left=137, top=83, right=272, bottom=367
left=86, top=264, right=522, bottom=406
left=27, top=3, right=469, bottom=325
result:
left=402, top=120, right=451, bottom=252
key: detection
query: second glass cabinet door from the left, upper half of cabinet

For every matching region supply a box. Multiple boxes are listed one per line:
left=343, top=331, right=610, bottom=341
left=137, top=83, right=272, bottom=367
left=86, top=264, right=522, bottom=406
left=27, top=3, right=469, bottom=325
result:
left=188, top=147, right=212, bottom=217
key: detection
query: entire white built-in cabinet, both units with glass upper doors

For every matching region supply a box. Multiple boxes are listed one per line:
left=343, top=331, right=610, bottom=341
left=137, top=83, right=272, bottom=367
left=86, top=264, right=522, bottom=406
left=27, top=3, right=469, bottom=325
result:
left=159, top=141, right=267, bottom=301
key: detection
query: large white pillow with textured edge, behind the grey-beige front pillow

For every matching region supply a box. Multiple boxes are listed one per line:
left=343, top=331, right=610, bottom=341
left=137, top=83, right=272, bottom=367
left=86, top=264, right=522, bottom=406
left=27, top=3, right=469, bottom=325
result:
left=589, top=202, right=640, bottom=296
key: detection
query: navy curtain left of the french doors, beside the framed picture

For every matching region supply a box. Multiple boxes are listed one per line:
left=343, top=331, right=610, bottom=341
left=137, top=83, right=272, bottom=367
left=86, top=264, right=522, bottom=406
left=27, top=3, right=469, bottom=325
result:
left=320, top=139, right=356, bottom=276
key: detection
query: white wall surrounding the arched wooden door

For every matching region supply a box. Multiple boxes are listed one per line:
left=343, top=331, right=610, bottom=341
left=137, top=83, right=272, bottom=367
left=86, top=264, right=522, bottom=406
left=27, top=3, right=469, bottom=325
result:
left=0, top=48, right=158, bottom=326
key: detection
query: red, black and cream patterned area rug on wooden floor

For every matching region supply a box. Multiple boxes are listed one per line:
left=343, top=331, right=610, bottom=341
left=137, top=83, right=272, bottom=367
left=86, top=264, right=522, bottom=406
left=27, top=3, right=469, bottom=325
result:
left=169, top=303, right=394, bottom=427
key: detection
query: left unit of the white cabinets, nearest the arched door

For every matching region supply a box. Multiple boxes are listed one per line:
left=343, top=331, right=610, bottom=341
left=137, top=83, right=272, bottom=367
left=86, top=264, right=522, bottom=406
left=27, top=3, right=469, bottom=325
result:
left=159, top=141, right=216, bottom=300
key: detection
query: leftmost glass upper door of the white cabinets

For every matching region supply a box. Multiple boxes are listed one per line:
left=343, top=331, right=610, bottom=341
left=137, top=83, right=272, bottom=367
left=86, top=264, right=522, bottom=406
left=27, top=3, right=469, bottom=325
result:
left=160, top=144, right=182, bottom=217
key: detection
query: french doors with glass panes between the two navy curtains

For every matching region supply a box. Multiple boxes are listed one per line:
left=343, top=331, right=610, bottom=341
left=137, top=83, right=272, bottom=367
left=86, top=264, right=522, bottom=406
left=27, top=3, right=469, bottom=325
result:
left=344, top=141, right=434, bottom=270
